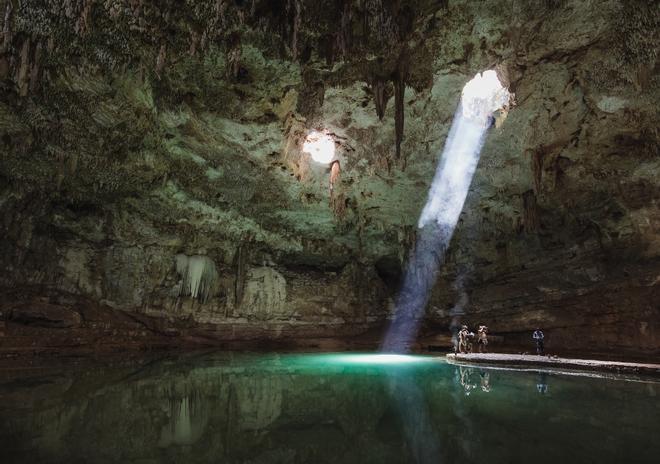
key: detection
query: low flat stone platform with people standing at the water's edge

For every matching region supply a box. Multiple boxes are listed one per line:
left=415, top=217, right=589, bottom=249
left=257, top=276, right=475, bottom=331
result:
left=447, top=353, right=660, bottom=376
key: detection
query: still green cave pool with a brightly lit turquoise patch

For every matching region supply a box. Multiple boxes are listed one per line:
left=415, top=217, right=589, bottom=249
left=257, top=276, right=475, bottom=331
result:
left=0, top=353, right=660, bottom=464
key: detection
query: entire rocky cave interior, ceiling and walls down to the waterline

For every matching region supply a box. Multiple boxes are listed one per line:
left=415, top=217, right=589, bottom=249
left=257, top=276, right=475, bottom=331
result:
left=0, top=0, right=660, bottom=355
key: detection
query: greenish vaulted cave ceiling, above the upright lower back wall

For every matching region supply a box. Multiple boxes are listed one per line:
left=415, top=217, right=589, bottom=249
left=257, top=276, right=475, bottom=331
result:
left=0, top=0, right=660, bottom=316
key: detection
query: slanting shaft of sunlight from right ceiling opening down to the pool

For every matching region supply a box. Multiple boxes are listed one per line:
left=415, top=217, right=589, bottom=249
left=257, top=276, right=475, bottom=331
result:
left=382, top=71, right=510, bottom=352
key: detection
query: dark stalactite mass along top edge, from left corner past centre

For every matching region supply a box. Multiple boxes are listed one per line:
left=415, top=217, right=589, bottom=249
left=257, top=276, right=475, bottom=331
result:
left=0, top=0, right=428, bottom=165
